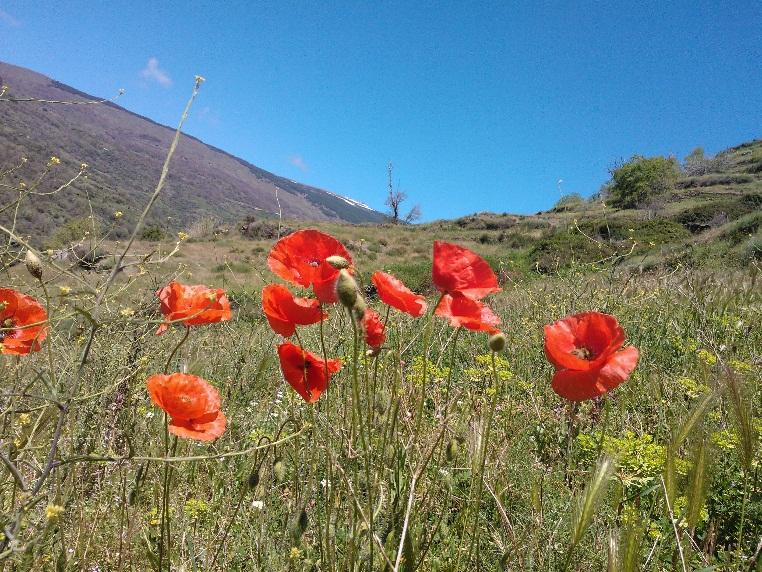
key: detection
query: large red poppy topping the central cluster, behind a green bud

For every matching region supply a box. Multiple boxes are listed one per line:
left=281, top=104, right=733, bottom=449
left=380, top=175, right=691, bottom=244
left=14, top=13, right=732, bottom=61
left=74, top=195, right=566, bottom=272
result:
left=267, top=229, right=352, bottom=303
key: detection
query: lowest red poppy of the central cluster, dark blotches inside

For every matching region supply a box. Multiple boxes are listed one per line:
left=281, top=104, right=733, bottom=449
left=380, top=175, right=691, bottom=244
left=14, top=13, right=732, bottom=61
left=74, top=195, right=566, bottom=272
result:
left=278, top=342, right=341, bottom=403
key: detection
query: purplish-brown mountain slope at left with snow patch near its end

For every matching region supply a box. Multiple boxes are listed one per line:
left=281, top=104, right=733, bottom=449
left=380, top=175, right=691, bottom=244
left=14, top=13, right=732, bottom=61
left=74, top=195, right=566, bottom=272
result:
left=0, top=62, right=384, bottom=244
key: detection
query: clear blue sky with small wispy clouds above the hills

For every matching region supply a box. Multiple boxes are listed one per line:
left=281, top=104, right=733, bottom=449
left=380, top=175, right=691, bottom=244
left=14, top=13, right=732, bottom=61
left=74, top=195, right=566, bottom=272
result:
left=0, top=0, right=762, bottom=220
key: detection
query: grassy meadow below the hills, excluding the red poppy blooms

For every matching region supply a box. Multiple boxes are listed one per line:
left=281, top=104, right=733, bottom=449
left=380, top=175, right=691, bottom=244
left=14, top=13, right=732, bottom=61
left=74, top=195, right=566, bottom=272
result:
left=0, top=91, right=762, bottom=572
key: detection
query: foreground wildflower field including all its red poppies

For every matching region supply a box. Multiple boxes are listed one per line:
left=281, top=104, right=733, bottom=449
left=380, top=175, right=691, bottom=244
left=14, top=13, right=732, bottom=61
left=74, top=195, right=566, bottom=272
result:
left=0, top=82, right=762, bottom=571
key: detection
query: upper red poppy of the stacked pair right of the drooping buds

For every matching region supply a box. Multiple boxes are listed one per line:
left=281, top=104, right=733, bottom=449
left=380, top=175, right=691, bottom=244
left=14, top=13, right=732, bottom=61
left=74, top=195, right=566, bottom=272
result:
left=431, top=240, right=500, bottom=300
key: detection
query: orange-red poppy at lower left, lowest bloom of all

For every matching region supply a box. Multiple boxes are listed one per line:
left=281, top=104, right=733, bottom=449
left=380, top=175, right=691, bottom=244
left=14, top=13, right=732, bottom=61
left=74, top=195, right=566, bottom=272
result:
left=146, top=373, right=227, bottom=441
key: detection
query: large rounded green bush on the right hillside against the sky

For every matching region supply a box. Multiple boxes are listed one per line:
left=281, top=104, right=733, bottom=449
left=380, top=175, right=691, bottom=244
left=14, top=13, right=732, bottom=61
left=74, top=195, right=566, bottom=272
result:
left=608, top=155, right=679, bottom=208
